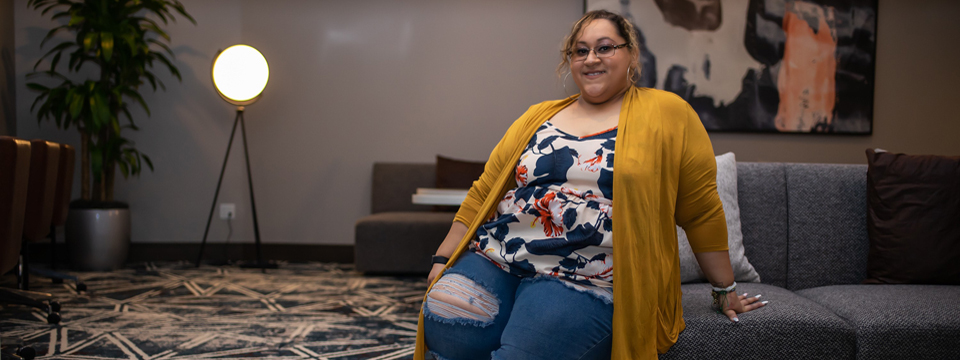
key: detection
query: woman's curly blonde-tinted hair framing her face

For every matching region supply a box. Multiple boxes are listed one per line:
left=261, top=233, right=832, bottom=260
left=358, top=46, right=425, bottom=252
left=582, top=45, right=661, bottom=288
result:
left=557, top=10, right=642, bottom=83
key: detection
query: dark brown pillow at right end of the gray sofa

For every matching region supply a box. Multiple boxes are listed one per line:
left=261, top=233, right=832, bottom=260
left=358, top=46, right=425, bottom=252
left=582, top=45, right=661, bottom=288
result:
left=864, top=150, right=960, bottom=284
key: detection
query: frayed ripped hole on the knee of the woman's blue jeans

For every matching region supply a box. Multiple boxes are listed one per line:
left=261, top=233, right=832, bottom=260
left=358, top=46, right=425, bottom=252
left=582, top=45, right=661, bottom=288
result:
left=424, top=273, right=500, bottom=327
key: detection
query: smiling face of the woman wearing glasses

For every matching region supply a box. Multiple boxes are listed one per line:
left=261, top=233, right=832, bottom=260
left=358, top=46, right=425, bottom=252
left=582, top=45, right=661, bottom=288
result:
left=570, top=19, right=632, bottom=103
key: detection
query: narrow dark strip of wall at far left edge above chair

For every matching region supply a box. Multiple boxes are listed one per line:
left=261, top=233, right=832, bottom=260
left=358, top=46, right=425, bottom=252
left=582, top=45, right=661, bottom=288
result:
left=0, top=0, right=17, bottom=135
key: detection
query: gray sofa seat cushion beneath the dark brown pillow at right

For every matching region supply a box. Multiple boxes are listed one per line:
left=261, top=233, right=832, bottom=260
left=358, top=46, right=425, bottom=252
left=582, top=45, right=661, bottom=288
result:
left=797, top=284, right=960, bottom=359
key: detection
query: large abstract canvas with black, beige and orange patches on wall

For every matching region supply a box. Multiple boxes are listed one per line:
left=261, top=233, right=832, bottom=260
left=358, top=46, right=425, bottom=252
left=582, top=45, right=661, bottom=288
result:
left=586, top=0, right=877, bottom=134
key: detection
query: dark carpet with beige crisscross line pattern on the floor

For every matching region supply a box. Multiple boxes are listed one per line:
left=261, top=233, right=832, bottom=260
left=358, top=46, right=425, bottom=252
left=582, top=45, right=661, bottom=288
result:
left=0, top=263, right=427, bottom=360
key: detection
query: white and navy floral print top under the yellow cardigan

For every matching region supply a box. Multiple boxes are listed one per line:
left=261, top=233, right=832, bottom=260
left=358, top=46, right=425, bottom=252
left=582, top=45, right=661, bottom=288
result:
left=473, top=122, right=617, bottom=287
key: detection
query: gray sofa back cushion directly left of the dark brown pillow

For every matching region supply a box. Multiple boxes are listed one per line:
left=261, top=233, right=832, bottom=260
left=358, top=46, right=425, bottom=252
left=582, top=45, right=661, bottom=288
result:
left=784, top=164, right=869, bottom=290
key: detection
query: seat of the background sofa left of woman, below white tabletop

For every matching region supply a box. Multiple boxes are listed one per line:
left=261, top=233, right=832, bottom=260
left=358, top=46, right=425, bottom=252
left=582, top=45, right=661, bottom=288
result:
left=354, top=211, right=456, bottom=274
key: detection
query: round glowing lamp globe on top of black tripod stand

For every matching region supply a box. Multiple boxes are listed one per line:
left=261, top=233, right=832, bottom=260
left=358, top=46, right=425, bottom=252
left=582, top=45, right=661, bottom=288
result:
left=212, top=45, right=270, bottom=105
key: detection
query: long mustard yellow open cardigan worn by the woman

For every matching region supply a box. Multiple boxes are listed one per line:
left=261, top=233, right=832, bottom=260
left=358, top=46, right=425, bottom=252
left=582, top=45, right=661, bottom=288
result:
left=415, top=87, right=727, bottom=360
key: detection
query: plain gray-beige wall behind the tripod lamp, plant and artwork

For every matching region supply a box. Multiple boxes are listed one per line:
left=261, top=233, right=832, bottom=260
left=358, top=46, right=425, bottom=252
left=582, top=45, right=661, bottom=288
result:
left=13, top=0, right=960, bottom=245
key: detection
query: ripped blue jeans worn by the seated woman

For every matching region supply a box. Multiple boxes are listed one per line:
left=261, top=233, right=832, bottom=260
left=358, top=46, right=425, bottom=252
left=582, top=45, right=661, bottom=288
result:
left=423, top=252, right=613, bottom=360
